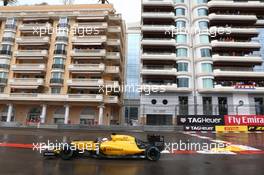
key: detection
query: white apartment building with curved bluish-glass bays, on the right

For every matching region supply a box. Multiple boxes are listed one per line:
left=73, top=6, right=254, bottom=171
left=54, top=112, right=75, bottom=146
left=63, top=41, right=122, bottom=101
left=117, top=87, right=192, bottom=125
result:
left=141, top=0, right=264, bottom=125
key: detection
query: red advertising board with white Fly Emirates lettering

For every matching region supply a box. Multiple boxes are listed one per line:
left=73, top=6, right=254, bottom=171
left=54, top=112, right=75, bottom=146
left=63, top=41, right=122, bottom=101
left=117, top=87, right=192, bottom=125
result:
left=224, top=115, right=264, bottom=126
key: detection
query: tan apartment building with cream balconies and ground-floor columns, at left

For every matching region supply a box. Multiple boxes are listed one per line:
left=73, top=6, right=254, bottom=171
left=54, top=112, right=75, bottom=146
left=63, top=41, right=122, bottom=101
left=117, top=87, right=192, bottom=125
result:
left=0, top=4, right=126, bottom=125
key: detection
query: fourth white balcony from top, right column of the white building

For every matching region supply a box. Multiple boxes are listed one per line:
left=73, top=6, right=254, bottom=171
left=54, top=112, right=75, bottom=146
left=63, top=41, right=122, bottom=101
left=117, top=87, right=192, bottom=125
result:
left=211, top=40, right=261, bottom=49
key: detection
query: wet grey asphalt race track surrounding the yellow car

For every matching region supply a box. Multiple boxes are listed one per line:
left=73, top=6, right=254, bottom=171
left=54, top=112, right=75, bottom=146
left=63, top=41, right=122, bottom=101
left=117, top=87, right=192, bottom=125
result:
left=0, top=129, right=264, bottom=175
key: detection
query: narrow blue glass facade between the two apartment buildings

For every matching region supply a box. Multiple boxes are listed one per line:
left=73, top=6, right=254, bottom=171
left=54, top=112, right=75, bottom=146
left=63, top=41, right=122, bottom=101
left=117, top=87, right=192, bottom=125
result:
left=124, top=23, right=141, bottom=125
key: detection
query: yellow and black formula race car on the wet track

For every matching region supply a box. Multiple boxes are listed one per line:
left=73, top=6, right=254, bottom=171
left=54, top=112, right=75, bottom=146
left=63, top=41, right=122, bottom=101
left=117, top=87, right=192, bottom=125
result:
left=43, top=134, right=164, bottom=161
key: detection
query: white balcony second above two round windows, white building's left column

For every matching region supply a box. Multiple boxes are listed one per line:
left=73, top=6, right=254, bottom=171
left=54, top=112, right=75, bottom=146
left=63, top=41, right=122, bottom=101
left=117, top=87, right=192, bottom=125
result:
left=141, top=66, right=177, bottom=76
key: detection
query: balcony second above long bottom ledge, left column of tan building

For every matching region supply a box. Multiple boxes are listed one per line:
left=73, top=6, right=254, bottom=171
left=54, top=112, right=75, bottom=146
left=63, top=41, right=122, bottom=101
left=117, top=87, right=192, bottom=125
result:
left=11, top=64, right=46, bottom=73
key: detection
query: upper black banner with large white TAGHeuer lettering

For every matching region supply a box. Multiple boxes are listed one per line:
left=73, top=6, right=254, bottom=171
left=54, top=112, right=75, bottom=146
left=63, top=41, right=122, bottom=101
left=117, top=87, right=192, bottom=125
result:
left=177, top=115, right=224, bottom=126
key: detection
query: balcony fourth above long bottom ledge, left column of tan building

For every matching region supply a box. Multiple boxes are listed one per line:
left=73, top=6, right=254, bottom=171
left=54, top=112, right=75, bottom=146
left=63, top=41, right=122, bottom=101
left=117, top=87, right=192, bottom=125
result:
left=16, top=36, right=50, bottom=45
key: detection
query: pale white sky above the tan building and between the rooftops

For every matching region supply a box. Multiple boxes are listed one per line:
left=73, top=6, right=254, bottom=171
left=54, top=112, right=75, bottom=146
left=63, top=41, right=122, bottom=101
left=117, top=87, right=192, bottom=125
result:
left=14, top=0, right=141, bottom=23
